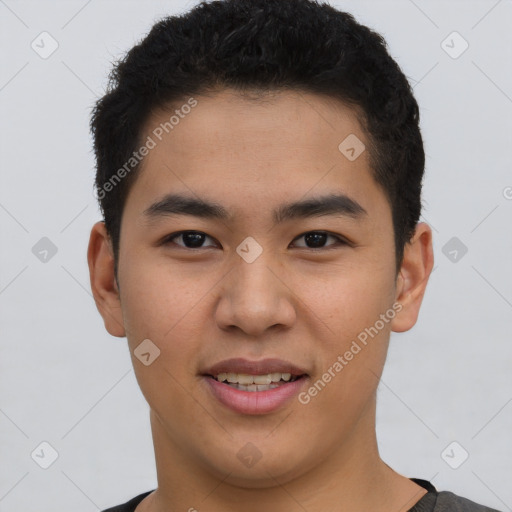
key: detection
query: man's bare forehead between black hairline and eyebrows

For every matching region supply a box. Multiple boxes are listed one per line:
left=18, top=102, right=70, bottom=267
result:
left=128, top=90, right=384, bottom=224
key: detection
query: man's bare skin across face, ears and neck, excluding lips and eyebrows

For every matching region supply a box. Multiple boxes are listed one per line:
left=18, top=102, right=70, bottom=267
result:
left=88, top=89, right=433, bottom=512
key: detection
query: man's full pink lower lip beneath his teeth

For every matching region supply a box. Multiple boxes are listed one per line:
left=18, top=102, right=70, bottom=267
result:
left=204, top=376, right=307, bottom=414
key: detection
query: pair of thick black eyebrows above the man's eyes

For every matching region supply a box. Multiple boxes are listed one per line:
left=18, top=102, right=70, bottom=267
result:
left=143, top=194, right=367, bottom=224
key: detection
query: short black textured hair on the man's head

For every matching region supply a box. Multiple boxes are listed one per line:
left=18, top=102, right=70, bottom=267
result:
left=91, top=0, right=425, bottom=274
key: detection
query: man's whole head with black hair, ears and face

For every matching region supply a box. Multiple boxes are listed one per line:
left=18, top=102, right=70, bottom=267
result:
left=89, top=0, right=432, bottom=485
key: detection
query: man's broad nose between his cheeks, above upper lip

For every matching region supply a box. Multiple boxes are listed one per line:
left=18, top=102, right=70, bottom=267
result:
left=215, top=251, right=296, bottom=337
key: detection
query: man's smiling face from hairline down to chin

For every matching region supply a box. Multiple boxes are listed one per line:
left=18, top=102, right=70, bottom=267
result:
left=88, top=90, right=428, bottom=487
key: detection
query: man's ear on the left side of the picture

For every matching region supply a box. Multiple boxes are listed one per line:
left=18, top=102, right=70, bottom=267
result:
left=87, top=221, right=126, bottom=338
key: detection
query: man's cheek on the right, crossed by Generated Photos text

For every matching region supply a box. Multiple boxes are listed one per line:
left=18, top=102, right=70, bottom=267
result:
left=305, top=267, right=395, bottom=414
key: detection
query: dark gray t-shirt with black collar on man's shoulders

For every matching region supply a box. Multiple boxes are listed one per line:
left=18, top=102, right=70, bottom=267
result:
left=103, top=478, right=500, bottom=512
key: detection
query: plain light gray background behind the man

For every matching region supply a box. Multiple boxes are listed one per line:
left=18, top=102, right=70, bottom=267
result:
left=0, top=0, right=512, bottom=512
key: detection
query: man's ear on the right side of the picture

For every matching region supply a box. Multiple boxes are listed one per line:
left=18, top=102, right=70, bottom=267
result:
left=391, top=222, right=434, bottom=332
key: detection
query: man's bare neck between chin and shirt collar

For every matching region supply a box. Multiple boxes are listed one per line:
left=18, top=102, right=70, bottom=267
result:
left=137, top=401, right=426, bottom=512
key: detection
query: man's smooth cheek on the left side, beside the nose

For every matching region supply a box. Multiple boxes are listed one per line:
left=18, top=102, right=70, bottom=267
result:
left=120, top=259, right=208, bottom=416
